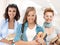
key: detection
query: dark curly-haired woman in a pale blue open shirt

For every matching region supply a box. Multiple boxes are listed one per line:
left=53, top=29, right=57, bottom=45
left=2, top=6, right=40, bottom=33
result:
left=0, top=4, right=20, bottom=45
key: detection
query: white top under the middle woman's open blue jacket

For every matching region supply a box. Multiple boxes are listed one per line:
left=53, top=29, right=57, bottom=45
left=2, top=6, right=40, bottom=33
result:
left=26, top=25, right=36, bottom=41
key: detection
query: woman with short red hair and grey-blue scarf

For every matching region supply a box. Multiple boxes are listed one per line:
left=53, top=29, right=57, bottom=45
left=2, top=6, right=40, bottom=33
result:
left=43, top=8, right=58, bottom=45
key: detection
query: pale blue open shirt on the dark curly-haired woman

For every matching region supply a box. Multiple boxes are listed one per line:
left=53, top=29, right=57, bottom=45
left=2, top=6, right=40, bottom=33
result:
left=0, top=19, right=19, bottom=45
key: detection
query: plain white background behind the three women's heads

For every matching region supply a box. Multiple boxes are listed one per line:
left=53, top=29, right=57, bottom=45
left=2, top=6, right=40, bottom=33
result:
left=0, top=0, right=60, bottom=27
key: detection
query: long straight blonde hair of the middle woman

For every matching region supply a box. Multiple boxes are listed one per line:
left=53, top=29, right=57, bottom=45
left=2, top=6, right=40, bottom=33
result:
left=22, top=7, right=37, bottom=33
